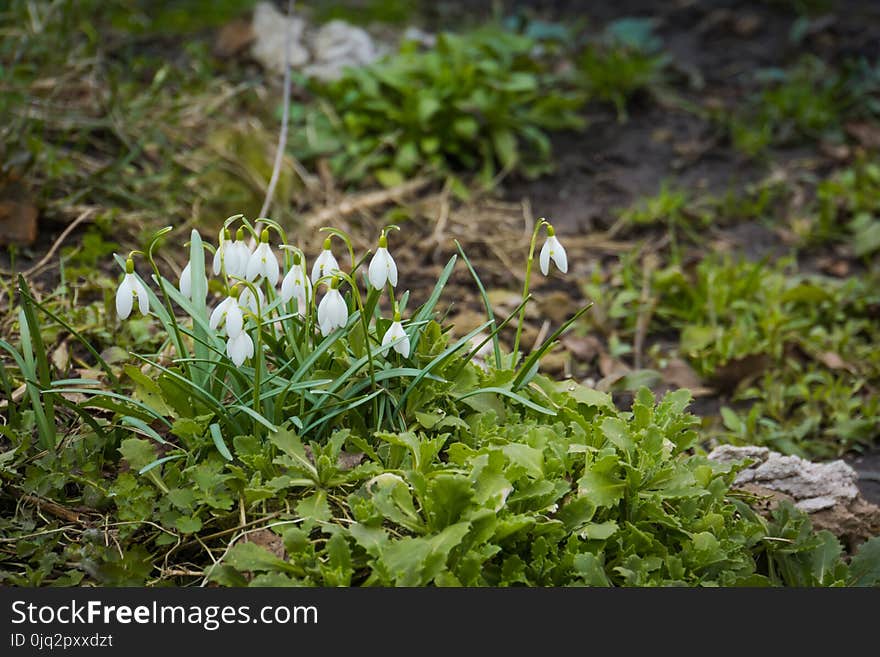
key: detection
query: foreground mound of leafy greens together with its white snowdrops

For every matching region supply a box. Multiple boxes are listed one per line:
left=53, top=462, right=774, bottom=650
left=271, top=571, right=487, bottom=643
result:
left=6, top=209, right=877, bottom=586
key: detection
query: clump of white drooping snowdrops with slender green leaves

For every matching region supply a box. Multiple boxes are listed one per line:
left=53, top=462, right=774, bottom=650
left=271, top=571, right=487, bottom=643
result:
left=103, top=215, right=586, bottom=458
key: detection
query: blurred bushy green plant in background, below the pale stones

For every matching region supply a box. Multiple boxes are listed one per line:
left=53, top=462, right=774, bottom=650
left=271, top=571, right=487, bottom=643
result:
left=291, top=28, right=583, bottom=185
